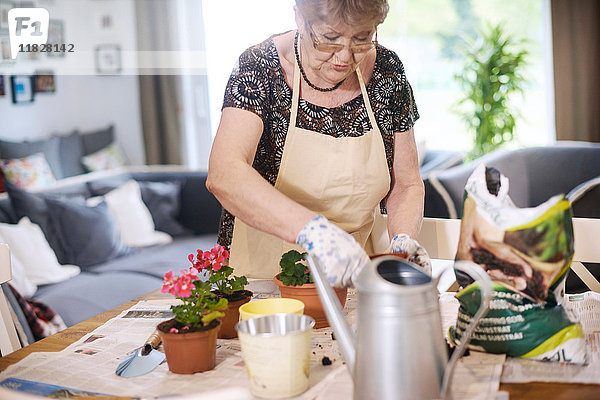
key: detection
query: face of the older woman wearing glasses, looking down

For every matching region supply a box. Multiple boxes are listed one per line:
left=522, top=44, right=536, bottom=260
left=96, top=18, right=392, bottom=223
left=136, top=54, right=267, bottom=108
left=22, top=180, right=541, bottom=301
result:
left=302, top=23, right=375, bottom=85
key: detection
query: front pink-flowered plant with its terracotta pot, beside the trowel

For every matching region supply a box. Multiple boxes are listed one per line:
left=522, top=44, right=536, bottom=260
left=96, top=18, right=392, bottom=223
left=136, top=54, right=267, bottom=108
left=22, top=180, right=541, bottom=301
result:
left=157, top=267, right=227, bottom=374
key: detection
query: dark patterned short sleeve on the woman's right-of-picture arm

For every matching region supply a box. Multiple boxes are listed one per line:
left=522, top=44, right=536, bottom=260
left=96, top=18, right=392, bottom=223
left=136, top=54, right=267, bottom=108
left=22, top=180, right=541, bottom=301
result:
left=388, top=51, right=419, bottom=132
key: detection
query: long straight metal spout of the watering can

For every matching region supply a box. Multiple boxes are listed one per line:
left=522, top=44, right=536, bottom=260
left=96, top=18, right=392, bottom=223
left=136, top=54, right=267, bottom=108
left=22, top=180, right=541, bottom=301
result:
left=306, top=254, right=356, bottom=374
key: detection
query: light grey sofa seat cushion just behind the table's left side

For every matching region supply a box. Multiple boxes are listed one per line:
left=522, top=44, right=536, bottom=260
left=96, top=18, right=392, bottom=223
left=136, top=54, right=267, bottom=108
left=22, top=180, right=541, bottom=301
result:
left=34, top=272, right=162, bottom=326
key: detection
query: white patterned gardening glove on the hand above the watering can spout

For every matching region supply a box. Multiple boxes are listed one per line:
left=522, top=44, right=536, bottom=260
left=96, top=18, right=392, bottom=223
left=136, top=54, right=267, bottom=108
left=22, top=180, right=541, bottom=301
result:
left=296, top=215, right=369, bottom=287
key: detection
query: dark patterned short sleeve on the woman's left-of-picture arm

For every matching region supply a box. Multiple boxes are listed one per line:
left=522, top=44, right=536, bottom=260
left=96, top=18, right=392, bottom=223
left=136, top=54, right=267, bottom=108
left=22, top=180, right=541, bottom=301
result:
left=223, top=46, right=269, bottom=118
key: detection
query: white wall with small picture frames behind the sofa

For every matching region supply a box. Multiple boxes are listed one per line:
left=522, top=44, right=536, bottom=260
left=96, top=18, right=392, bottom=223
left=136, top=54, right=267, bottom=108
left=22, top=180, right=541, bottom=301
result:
left=0, top=0, right=145, bottom=164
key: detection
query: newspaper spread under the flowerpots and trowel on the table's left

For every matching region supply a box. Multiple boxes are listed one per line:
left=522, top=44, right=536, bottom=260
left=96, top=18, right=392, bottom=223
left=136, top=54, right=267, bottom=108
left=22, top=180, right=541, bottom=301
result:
left=0, top=281, right=356, bottom=400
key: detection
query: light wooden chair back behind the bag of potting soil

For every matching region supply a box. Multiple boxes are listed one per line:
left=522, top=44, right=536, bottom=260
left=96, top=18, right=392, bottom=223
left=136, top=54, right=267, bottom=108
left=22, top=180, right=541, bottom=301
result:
left=418, top=218, right=600, bottom=292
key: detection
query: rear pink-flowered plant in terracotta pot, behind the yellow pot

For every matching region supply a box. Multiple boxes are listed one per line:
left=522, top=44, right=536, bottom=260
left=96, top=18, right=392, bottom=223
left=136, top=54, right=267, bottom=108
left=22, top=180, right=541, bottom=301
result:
left=188, top=244, right=252, bottom=339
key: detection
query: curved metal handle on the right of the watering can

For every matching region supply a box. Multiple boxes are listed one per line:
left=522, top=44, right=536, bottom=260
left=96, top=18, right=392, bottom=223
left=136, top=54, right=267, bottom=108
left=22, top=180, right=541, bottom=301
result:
left=441, top=261, right=494, bottom=400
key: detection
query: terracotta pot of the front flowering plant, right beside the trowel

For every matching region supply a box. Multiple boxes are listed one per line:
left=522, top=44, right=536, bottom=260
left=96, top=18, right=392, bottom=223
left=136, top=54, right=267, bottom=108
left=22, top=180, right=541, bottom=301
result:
left=157, top=319, right=221, bottom=374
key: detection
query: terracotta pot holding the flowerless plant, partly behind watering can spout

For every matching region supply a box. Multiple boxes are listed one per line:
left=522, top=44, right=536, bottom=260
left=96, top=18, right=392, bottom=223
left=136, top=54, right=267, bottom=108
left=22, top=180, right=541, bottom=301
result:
left=273, top=274, right=348, bottom=329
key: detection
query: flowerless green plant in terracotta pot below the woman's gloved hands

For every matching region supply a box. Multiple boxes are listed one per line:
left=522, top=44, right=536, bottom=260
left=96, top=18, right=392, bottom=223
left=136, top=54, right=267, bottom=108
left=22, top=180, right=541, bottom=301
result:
left=273, top=250, right=348, bottom=328
